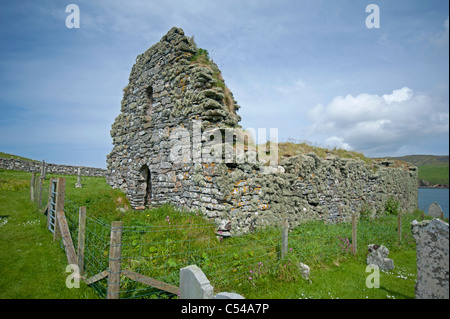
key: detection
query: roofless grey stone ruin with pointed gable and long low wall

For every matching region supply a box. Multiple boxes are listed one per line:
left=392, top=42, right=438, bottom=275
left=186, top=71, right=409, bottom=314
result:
left=106, top=27, right=417, bottom=234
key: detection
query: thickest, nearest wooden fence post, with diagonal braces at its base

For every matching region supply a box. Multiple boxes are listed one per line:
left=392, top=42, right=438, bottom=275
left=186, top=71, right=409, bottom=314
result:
left=107, top=221, right=122, bottom=299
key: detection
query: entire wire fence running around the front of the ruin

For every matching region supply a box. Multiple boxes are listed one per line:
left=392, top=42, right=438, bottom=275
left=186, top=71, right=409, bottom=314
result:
left=30, top=175, right=415, bottom=299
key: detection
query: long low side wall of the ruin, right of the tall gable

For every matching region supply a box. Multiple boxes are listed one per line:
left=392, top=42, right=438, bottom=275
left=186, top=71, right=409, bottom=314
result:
left=214, top=154, right=418, bottom=232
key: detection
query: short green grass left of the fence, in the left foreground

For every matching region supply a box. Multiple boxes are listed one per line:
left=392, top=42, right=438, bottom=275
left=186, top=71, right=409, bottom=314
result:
left=0, top=170, right=97, bottom=299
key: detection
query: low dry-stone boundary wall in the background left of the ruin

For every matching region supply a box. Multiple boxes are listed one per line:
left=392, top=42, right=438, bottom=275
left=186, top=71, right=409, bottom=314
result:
left=0, top=158, right=106, bottom=177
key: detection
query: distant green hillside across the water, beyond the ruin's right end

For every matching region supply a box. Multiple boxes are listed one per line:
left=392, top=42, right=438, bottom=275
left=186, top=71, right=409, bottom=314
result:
left=388, top=155, right=449, bottom=187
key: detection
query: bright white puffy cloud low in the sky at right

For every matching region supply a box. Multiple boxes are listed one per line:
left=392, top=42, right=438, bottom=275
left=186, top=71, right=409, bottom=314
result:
left=308, top=87, right=449, bottom=156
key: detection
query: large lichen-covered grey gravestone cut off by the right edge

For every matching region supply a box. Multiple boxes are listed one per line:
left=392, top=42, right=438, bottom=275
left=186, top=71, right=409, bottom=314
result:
left=411, top=219, right=449, bottom=299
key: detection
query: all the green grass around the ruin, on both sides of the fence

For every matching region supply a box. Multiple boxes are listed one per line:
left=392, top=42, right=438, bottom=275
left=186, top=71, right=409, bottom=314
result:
left=0, top=170, right=428, bottom=299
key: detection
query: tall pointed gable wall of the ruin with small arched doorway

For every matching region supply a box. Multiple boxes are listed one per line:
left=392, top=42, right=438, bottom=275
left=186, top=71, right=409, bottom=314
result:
left=107, top=28, right=240, bottom=208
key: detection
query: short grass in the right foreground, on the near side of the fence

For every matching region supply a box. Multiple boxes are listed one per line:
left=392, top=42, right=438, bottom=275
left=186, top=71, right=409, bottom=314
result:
left=239, top=251, right=416, bottom=299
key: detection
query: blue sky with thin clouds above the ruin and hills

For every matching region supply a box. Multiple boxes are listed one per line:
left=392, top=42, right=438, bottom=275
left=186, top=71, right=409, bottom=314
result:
left=0, top=0, right=449, bottom=168
